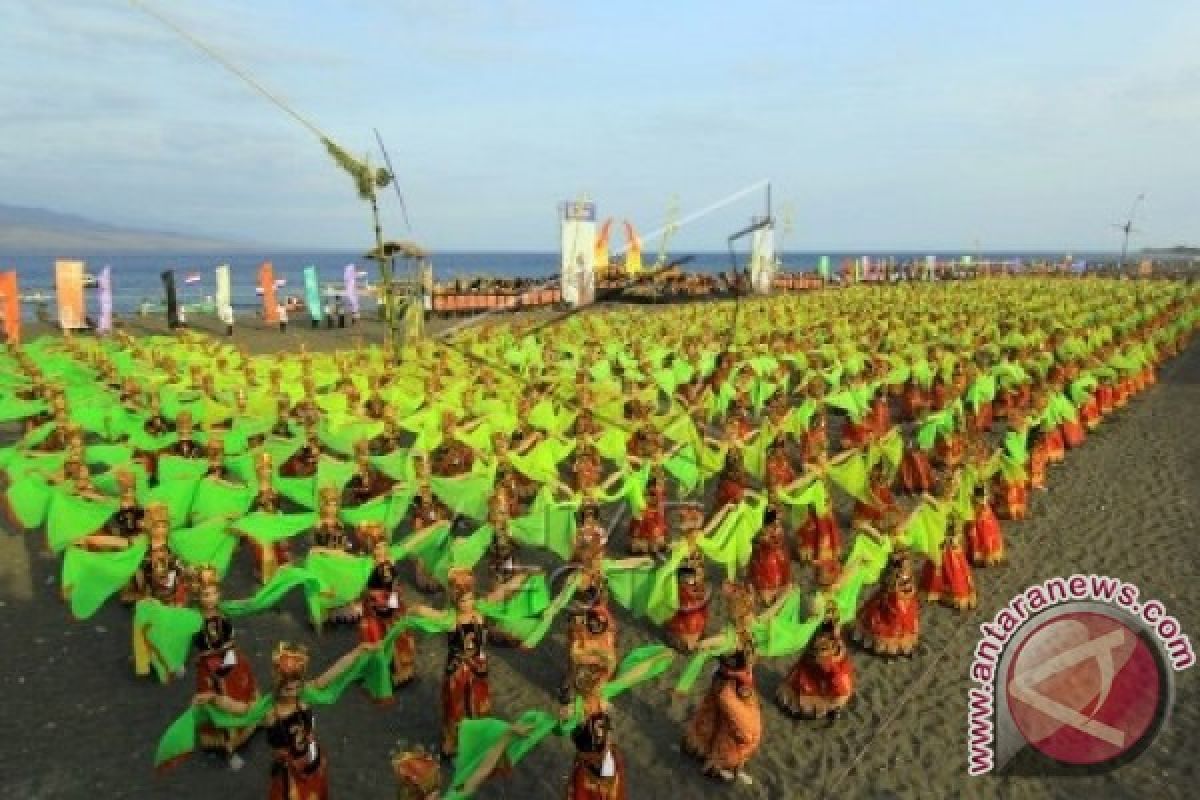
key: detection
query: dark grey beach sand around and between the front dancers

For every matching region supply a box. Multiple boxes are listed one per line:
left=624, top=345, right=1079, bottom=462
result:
left=0, top=309, right=1200, bottom=800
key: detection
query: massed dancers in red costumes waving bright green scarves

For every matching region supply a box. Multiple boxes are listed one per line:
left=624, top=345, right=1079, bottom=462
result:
left=0, top=278, right=1200, bottom=800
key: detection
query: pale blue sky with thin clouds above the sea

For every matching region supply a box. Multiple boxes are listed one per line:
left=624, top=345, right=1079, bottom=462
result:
left=0, top=0, right=1200, bottom=249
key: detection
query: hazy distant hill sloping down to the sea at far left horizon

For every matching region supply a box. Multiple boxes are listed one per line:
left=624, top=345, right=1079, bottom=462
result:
left=0, top=204, right=247, bottom=253
